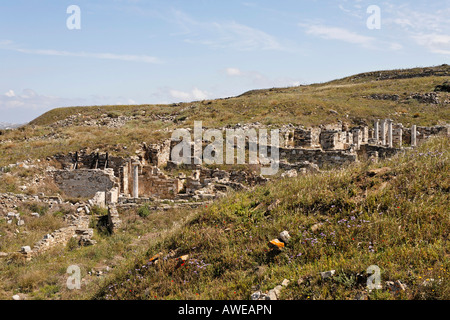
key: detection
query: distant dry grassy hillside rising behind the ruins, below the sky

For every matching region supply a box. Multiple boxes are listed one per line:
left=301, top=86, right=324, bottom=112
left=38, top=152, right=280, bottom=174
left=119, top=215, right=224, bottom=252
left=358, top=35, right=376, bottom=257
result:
left=0, top=65, right=450, bottom=167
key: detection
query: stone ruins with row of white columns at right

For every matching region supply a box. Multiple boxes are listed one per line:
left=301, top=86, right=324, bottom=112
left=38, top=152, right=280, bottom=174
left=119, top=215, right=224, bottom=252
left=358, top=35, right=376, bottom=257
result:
left=280, top=119, right=450, bottom=169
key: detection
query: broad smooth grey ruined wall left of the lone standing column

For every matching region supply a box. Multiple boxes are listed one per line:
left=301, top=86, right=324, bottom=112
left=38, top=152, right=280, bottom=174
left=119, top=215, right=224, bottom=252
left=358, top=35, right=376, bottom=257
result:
left=53, top=169, right=118, bottom=198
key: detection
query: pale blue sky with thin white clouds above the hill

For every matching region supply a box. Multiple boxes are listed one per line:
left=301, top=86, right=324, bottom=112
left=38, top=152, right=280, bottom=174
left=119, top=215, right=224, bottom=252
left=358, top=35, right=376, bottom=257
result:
left=0, top=0, right=450, bottom=123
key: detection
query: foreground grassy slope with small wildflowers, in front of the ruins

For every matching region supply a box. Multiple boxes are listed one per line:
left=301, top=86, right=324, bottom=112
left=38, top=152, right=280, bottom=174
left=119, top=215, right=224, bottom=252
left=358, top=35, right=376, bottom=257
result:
left=92, top=138, right=450, bottom=299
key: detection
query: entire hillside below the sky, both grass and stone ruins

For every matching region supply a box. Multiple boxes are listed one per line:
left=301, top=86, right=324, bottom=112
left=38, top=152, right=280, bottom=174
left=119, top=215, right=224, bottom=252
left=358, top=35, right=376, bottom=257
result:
left=0, top=65, right=450, bottom=300
